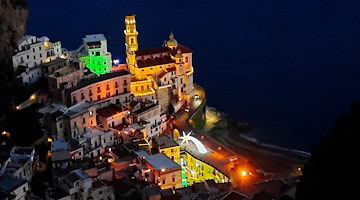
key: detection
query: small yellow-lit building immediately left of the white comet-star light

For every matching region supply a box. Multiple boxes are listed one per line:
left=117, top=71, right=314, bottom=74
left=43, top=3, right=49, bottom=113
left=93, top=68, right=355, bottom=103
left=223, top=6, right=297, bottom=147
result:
left=156, top=135, right=180, bottom=163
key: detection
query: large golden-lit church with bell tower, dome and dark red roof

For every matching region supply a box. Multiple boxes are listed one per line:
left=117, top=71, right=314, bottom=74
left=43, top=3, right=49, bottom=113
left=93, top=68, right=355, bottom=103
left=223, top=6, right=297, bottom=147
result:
left=124, top=15, right=194, bottom=112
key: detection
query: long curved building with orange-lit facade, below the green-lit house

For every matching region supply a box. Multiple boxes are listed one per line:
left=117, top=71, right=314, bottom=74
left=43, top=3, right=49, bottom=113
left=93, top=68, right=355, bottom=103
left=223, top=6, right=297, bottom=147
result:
left=63, top=71, right=130, bottom=105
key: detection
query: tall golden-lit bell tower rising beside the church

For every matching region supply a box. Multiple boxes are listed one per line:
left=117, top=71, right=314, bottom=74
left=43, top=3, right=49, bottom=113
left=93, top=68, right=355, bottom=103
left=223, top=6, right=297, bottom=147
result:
left=124, top=15, right=139, bottom=74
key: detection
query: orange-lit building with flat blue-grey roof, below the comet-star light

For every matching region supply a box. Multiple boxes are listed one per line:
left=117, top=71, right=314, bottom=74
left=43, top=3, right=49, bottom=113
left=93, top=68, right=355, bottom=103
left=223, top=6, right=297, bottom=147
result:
left=134, top=151, right=182, bottom=189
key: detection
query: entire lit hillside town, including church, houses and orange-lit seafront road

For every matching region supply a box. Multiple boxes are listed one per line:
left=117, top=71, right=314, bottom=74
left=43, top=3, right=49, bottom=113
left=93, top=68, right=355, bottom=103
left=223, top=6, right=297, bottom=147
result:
left=0, top=15, right=302, bottom=200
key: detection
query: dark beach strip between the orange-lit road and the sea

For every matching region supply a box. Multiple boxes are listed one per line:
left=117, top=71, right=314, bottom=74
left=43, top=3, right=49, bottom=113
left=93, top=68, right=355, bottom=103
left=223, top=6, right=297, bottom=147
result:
left=204, top=107, right=310, bottom=178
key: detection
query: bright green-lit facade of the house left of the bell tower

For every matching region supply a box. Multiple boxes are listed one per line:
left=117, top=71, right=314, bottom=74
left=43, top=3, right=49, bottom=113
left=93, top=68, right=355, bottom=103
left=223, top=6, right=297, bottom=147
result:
left=80, top=55, right=111, bottom=75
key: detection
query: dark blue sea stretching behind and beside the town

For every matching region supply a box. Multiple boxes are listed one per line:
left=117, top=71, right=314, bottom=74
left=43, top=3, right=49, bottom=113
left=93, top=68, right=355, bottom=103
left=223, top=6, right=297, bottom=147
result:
left=27, top=0, right=360, bottom=151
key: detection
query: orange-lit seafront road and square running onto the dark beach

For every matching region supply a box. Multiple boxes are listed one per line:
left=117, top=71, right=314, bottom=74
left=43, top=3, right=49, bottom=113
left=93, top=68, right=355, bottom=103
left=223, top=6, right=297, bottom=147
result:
left=173, top=86, right=306, bottom=187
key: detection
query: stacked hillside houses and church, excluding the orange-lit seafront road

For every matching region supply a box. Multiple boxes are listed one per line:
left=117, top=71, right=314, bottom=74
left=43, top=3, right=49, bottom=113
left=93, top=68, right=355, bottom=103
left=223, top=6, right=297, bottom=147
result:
left=0, top=15, right=298, bottom=200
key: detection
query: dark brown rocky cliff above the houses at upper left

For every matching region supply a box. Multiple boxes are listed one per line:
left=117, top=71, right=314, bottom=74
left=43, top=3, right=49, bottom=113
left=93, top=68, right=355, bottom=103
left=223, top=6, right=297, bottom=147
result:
left=0, top=0, right=28, bottom=115
